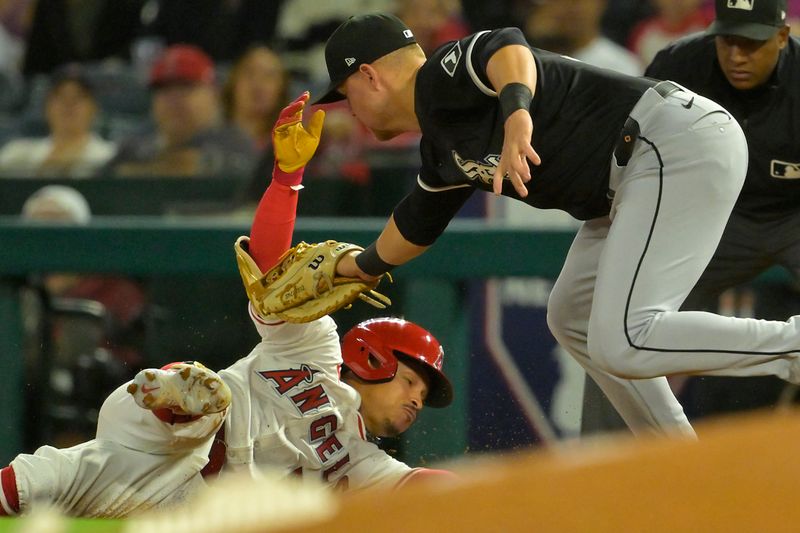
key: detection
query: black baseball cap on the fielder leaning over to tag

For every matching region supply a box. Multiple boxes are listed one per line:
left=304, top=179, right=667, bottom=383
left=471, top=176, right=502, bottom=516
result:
left=314, top=13, right=417, bottom=104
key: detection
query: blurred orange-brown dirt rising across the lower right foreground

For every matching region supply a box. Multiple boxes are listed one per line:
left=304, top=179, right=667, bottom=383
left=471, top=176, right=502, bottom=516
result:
left=280, top=412, right=800, bottom=533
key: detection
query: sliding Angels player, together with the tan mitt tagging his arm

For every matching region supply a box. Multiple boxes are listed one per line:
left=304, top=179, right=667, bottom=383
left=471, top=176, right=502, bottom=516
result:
left=0, top=93, right=453, bottom=517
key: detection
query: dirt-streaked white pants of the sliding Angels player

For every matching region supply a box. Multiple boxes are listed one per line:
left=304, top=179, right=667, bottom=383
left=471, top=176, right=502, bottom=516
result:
left=11, top=385, right=224, bottom=517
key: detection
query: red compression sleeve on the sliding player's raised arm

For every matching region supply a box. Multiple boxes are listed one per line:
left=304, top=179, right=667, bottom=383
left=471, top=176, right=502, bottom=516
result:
left=249, top=180, right=298, bottom=272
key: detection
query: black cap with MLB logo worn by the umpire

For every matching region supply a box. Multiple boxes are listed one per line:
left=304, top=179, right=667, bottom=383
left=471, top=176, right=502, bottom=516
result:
left=706, top=0, right=786, bottom=41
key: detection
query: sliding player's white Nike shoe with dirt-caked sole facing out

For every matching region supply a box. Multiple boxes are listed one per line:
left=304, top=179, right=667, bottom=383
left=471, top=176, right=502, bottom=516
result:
left=128, top=362, right=231, bottom=415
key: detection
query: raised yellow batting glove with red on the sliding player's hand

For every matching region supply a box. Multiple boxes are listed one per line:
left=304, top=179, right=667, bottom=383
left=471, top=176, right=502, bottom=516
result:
left=272, top=91, right=325, bottom=172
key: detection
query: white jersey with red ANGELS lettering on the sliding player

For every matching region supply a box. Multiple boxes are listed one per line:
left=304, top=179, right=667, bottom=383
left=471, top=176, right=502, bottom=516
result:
left=220, top=307, right=412, bottom=489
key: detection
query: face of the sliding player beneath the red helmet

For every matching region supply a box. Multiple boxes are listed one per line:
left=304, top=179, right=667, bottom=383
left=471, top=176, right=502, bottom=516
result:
left=354, top=362, right=428, bottom=437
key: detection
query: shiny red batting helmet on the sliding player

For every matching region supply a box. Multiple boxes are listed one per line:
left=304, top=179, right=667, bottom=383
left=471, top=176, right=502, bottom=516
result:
left=342, top=318, right=453, bottom=407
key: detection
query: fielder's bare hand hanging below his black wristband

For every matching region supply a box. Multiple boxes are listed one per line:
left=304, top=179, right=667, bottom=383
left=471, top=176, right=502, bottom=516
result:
left=492, top=109, right=542, bottom=198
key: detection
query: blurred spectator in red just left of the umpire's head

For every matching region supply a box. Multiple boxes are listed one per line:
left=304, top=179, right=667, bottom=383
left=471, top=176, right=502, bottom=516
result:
left=628, top=0, right=714, bottom=65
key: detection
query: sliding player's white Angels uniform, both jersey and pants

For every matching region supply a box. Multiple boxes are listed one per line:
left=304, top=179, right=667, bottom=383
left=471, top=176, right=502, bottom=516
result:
left=11, top=304, right=414, bottom=517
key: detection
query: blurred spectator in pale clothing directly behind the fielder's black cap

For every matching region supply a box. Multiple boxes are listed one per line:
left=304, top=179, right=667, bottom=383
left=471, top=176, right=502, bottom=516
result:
left=275, top=0, right=394, bottom=88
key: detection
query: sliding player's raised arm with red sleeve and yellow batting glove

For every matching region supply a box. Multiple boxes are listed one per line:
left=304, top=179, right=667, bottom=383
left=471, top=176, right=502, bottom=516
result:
left=248, top=92, right=325, bottom=272
